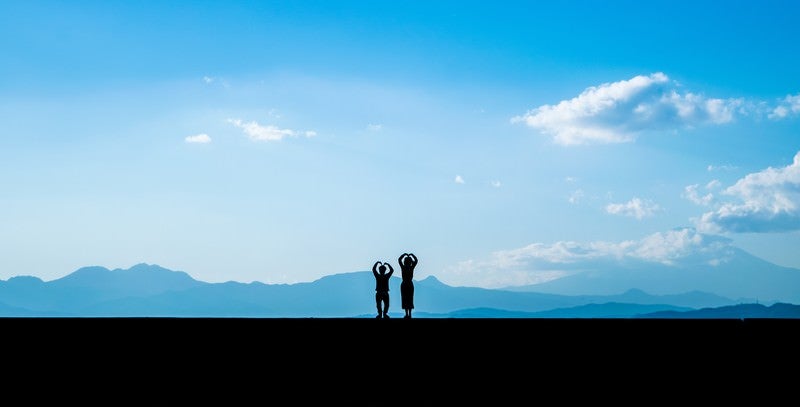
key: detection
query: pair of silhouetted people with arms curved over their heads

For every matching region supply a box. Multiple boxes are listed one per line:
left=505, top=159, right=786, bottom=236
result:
left=372, top=253, right=417, bottom=318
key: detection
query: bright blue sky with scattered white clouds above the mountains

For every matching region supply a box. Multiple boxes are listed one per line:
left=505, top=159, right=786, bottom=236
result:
left=0, top=0, right=800, bottom=287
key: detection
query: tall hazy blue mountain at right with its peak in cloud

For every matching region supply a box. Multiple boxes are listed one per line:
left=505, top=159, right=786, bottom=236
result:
left=506, top=246, right=800, bottom=303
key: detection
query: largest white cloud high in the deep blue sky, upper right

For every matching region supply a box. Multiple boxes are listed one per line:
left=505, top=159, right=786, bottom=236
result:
left=511, top=72, right=744, bottom=145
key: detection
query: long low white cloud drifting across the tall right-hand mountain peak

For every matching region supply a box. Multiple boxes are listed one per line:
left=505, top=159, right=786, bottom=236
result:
left=441, top=228, right=730, bottom=288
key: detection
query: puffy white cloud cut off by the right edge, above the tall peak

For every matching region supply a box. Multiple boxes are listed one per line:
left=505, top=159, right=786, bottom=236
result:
left=695, top=152, right=800, bottom=233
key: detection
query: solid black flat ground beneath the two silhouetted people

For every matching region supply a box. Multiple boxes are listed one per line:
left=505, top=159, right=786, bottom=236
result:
left=0, top=318, right=800, bottom=405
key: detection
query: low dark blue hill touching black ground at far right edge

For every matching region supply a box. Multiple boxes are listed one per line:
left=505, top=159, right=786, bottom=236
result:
left=639, top=303, right=800, bottom=319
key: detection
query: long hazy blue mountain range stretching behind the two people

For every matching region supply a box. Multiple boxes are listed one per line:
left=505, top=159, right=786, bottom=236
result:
left=0, top=264, right=756, bottom=318
